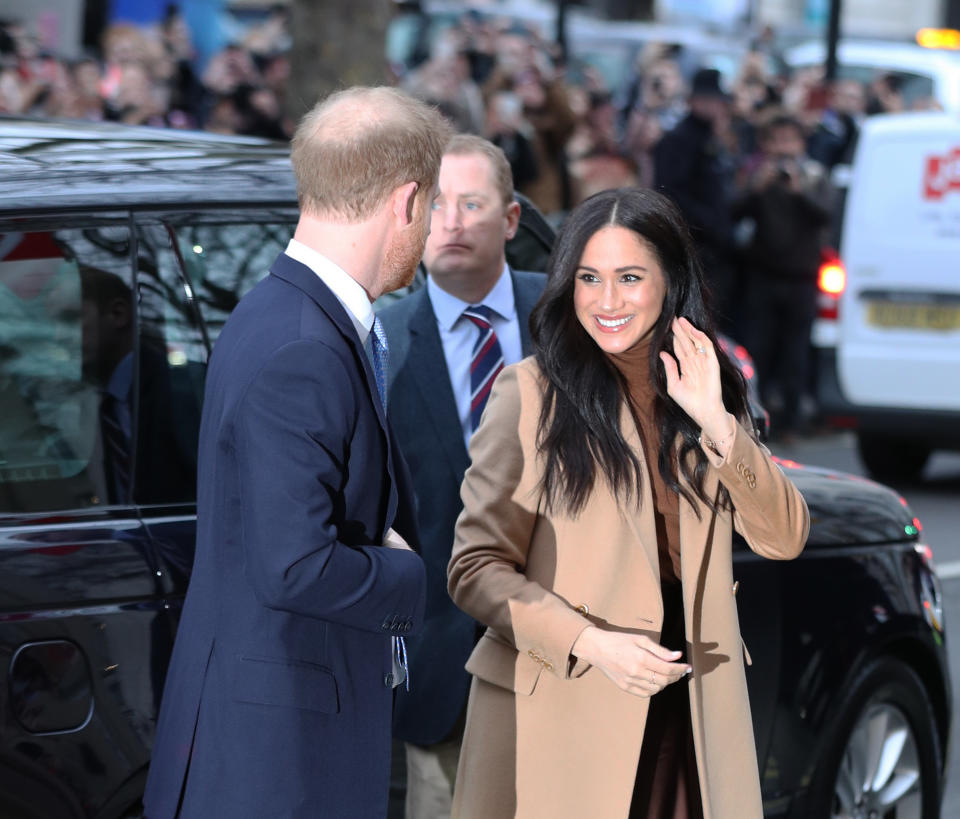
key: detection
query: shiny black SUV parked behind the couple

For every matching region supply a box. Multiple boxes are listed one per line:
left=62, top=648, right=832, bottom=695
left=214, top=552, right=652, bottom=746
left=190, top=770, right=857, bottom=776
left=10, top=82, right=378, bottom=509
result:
left=0, top=118, right=951, bottom=819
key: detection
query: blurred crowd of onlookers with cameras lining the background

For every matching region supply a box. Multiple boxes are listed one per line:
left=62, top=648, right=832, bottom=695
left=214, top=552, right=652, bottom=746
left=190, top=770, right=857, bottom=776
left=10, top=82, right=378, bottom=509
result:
left=0, top=6, right=928, bottom=436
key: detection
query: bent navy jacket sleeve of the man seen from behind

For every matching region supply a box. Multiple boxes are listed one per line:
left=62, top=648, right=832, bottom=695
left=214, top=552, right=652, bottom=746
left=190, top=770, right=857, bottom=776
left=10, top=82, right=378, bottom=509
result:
left=233, top=341, right=426, bottom=633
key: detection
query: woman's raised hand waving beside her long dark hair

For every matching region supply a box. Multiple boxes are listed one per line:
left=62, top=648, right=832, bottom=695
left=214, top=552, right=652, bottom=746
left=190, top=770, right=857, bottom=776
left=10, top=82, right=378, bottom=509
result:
left=660, top=317, right=734, bottom=452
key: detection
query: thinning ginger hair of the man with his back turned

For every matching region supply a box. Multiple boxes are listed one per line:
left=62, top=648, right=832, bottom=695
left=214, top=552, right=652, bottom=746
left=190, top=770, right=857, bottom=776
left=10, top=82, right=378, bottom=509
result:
left=290, top=87, right=451, bottom=221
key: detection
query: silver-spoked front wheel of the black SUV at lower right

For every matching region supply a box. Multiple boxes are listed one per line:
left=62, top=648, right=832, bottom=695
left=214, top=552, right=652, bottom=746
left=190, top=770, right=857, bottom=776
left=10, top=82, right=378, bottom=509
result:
left=806, top=658, right=940, bottom=819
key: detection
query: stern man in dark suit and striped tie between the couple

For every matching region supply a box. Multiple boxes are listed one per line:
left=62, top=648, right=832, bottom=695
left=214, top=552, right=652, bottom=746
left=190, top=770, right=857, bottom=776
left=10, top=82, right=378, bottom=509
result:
left=380, top=135, right=546, bottom=819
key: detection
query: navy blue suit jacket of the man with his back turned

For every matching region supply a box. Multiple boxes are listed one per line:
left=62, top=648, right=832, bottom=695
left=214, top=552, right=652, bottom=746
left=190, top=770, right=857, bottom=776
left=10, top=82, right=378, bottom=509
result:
left=144, top=255, right=425, bottom=819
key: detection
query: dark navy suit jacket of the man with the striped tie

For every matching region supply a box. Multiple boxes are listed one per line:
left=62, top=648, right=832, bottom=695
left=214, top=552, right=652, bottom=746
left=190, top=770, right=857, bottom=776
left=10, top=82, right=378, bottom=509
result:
left=379, top=271, right=547, bottom=745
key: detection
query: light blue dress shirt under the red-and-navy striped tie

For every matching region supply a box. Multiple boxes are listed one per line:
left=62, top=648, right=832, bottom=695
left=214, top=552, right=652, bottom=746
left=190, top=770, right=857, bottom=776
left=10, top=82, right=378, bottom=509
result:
left=427, top=265, right=523, bottom=446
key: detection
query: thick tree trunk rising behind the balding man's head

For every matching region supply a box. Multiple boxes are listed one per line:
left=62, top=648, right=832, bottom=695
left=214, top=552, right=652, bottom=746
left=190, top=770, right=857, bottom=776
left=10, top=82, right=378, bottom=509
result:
left=286, top=0, right=393, bottom=122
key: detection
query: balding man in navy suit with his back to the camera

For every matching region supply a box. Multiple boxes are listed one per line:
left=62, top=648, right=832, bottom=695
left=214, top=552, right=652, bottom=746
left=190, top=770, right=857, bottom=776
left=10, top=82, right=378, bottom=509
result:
left=144, top=88, right=450, bottom=819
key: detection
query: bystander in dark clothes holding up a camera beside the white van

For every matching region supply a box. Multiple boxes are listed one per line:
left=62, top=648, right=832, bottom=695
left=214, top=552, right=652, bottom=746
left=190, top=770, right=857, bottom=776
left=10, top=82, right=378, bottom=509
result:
left=733, top=113, right=836, bottom=438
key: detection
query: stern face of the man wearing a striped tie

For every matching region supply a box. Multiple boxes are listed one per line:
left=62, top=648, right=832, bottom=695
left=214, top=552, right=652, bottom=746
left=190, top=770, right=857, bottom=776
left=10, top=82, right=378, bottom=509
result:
left=423, top=153, right=520, bottom=301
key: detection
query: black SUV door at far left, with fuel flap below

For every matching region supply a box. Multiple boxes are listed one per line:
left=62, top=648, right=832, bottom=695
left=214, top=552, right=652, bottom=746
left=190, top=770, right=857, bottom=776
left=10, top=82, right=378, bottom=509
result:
left=0, top=212, right=169, bottom=819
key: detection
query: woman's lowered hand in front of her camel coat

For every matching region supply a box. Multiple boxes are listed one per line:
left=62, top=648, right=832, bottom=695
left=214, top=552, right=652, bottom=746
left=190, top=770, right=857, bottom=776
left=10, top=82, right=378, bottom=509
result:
left=573, top=626, right=692, bottom=697
